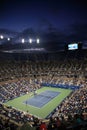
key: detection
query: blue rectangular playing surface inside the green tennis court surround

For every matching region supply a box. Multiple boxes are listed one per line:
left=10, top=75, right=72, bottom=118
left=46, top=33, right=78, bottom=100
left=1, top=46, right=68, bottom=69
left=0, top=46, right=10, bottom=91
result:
left=23, top=90, right=60, bottom=108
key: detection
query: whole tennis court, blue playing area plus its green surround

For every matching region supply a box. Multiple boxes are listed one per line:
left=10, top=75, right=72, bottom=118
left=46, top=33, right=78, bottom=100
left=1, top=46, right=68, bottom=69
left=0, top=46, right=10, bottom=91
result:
left=5, top=87, right=72, bottom=118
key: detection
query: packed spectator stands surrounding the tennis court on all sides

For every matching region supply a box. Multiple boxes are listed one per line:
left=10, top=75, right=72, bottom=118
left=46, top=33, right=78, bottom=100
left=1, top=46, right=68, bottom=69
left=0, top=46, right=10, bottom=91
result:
left=0, top=50, right=87, bottom=130
